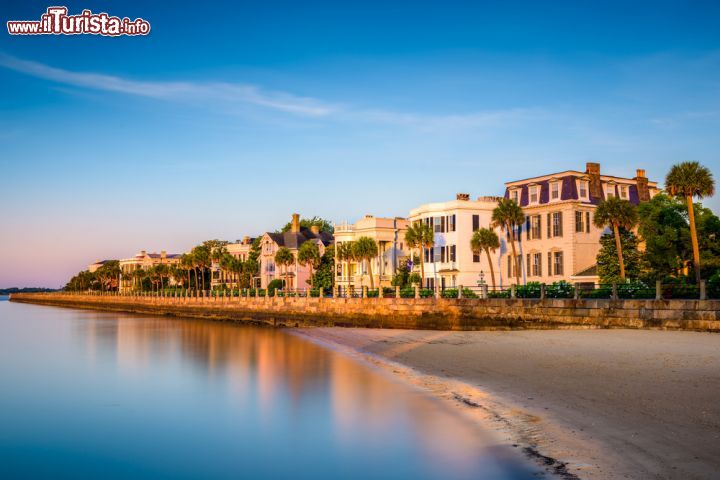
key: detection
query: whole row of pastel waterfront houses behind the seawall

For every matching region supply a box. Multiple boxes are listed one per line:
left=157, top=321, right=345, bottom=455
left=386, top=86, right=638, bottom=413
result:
left=101, top=163, right=659, bottom=290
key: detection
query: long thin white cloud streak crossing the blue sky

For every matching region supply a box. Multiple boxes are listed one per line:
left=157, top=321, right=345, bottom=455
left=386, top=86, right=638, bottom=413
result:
left=0, top=52, right=545, bottom=131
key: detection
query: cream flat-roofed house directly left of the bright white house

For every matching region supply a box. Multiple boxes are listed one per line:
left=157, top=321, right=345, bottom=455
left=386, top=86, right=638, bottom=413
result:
left=335, top=215, right=409, bottom=290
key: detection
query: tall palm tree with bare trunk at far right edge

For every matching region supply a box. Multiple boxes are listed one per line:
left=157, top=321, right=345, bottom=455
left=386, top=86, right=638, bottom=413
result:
left=665, top=162, right=715, bottom=284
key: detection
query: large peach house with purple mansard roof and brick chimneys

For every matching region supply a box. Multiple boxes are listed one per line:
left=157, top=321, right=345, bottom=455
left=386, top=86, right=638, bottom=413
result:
left=501, top=163, right=659, bottom=284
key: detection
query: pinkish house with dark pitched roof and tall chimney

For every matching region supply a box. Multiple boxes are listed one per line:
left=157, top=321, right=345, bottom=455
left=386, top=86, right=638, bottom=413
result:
left=259, top=213, right=333, bottom=289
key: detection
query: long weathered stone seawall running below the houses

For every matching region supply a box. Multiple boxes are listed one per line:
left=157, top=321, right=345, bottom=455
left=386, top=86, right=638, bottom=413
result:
left=10, top=293, right=720, bottom=332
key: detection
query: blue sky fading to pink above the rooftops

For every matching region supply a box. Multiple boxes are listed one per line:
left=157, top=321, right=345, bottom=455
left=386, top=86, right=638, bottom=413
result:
left=0, top=1, right=720, bottom=287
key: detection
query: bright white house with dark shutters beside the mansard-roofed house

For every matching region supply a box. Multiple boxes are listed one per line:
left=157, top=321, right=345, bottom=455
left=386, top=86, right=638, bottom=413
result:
left=408, top=193, right=500, bottom=288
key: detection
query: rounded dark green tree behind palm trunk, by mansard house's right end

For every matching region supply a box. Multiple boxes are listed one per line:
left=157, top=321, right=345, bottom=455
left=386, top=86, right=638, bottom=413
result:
left=597, top=228, right=643, bottom=284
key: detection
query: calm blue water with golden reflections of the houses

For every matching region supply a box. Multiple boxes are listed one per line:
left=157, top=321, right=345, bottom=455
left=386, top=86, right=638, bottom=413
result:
left=0, top=301, right=529, bottom=479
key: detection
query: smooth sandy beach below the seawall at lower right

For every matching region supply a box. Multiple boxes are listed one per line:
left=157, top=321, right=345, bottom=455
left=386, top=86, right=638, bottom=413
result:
left=300, top=328, right=720, bottom=479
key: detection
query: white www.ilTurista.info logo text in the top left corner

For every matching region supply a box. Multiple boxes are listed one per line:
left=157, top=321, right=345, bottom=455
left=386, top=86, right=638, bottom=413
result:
left=7, top=7, right=150, bottom=37
